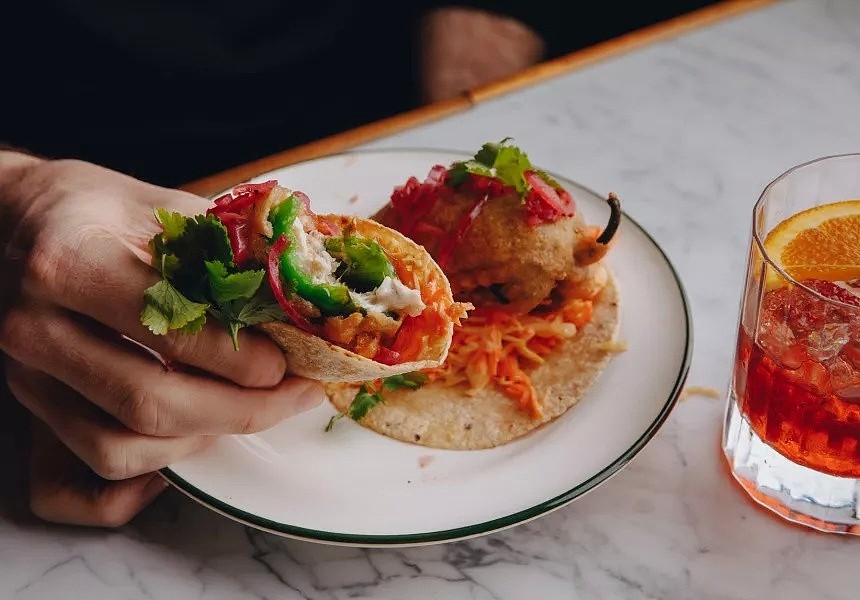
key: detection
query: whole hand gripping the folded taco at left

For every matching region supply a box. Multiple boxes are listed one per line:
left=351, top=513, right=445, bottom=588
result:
left=0, top=152, right=324, bottom=526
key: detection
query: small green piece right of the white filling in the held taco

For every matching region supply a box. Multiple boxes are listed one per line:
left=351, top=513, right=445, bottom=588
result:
left=325, top=235, right=396, bottom=292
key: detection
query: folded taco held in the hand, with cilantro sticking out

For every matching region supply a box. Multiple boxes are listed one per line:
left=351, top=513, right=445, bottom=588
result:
left=141, top=181, right=468, bottom=381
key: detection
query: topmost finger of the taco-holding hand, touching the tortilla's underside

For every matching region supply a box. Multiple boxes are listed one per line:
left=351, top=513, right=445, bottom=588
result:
left=20, top=232, right=286, bottom=387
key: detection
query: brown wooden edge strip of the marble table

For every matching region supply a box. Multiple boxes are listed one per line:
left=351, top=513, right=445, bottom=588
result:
left=182, top=0, right=779, bottom=197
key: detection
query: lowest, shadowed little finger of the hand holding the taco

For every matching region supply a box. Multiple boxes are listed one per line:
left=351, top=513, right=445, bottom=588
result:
left=30, top=419, right=168, bottom=527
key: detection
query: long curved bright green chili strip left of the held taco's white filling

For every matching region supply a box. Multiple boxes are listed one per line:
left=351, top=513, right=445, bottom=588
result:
left=269, top=195, right=356, bottom=316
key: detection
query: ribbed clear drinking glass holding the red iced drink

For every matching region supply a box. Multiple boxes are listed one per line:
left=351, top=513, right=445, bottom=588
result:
left=722, top=154, right=860, bottom=534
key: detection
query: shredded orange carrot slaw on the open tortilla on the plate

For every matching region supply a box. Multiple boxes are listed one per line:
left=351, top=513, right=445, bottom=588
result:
left=425, top=298, right=593, bottom=419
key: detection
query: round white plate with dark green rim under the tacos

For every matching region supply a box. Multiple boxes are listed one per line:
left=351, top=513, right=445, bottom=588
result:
left=163, top=150, right=692, bottom=546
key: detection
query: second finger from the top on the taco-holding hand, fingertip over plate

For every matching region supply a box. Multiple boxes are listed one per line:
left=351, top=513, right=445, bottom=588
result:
left=0, top=307, right=325, bottom=437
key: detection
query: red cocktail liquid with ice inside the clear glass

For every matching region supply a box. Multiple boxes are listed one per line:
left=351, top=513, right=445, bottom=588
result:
left=735, top=280, right=860, bottom=477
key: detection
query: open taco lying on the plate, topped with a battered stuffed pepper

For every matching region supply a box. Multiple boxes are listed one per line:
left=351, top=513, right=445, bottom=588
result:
left=326, top=140, right=621, bottom=449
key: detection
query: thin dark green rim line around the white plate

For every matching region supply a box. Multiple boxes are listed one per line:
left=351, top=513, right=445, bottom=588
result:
left=161, top=148, right=693, bottom=546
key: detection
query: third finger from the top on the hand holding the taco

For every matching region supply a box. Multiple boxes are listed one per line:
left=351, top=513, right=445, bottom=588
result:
left=7, top=360, right=215, bottom=480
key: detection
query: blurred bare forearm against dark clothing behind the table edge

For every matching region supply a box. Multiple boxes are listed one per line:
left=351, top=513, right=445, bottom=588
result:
left=421, top=8, right=545, bottom=102
